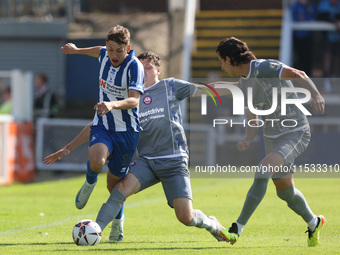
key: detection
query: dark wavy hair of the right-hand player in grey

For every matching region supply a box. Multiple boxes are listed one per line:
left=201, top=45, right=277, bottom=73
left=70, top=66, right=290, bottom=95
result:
left=216, top=37, right=256, bottom=66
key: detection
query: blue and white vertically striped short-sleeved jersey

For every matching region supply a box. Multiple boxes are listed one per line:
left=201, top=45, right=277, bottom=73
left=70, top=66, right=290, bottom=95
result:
left=92, top=47, right=144, bottom=132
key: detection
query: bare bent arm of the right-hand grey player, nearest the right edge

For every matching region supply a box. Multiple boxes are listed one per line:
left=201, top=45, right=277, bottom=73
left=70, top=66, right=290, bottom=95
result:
left=281, top=66, right=325, bottom=114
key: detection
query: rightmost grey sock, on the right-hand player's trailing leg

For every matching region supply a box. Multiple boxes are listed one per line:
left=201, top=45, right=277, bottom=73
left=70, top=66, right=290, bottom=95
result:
left=276, top=185, right=314, bottom=223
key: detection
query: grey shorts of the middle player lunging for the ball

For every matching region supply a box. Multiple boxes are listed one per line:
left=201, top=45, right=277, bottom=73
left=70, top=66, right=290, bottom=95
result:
left=129, top=157, right=192, bottom=208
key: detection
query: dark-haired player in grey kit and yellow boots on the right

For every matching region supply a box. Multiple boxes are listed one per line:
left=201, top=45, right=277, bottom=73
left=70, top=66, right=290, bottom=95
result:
left=216, top=37, right=325, bottom=246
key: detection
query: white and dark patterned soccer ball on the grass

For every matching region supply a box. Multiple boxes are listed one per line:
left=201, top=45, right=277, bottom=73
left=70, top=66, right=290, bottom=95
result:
left=72, top=220, right=102, bottom=246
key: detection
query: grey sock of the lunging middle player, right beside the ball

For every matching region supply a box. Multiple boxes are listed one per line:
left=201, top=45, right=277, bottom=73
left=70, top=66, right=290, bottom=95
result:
left=96, top=188, right=126, bottom=231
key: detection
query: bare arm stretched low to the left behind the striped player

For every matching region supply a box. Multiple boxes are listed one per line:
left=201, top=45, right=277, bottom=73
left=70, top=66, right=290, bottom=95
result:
left=44, top=122, right=92, bottom=165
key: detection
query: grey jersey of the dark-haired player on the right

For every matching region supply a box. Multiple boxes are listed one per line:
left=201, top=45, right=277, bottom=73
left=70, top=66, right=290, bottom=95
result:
left=239, top=59, right=308, bottom=137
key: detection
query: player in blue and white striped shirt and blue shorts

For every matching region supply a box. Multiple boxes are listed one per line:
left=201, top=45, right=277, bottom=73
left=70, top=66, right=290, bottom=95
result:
left=61, top=25, right=144, bottom=241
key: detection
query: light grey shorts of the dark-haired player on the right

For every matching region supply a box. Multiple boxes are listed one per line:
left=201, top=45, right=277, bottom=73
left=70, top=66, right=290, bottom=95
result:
left=264, top=127, right=311, bottom=179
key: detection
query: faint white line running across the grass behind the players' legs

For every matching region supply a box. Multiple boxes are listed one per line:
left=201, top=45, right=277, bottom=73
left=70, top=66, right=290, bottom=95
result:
left=0, top=179, right=244, bottom=236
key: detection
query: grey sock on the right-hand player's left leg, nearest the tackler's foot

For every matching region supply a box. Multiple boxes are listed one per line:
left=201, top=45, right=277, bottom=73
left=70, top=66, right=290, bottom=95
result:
left=237, top=173, right=270, bottom=225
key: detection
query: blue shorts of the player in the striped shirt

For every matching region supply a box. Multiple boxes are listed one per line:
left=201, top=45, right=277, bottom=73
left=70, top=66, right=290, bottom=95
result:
left=89, top=126, right=139, bottom=177
